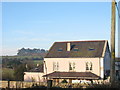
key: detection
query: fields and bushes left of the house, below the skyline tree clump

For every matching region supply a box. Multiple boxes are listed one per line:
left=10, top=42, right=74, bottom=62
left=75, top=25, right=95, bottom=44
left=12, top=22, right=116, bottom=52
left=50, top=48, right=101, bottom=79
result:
left=0, top=51, right=43, bottom=80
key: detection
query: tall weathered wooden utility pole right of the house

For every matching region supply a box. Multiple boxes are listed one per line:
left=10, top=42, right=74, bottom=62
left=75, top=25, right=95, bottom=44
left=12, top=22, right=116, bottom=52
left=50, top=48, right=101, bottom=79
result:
left=110, top=0, right=116, bottom=85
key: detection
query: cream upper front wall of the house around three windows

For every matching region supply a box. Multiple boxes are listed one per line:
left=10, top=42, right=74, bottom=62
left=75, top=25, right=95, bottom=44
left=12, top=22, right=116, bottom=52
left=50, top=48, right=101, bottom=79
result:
left=44, top=58, right=101, bottom=76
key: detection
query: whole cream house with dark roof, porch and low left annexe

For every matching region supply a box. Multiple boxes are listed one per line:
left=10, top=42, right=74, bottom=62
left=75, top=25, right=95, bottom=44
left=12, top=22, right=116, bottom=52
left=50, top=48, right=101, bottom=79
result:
left=24, top=40, right=115, bottom=82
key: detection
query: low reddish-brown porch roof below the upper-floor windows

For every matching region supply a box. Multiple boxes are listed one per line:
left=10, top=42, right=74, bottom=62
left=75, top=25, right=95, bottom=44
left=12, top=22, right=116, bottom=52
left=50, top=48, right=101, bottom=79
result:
left=43, top=72, right=100, bottom=79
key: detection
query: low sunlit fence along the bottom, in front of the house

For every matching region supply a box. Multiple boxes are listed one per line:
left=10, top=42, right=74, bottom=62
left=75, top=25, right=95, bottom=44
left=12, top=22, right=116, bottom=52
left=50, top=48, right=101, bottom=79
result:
left=0, top=80, right=108, bottom=88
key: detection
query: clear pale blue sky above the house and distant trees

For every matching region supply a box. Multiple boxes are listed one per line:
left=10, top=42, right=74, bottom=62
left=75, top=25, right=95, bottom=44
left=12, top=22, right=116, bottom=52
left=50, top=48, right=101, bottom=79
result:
left=2, top=2, right=118, bottom=55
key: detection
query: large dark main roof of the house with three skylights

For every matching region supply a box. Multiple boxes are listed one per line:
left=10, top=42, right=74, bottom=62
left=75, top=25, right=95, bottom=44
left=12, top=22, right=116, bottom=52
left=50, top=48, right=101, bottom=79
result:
left=45, top=40, right=106, bottom=58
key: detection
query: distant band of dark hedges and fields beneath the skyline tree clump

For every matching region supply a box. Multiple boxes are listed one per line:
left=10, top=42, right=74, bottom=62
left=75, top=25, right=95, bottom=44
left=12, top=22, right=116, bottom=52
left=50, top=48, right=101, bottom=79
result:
left=2, top=56, right=43, bottom=69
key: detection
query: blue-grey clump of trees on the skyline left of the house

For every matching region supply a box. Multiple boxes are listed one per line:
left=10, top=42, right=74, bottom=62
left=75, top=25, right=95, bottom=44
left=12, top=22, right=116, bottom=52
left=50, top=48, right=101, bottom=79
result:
left=17, top=48, right=48, bottom=57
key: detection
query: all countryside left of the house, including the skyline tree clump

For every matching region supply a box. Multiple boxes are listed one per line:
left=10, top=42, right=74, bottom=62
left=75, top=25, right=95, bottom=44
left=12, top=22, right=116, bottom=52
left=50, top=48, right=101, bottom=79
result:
left=0, top=48, right=48, bottom=80
